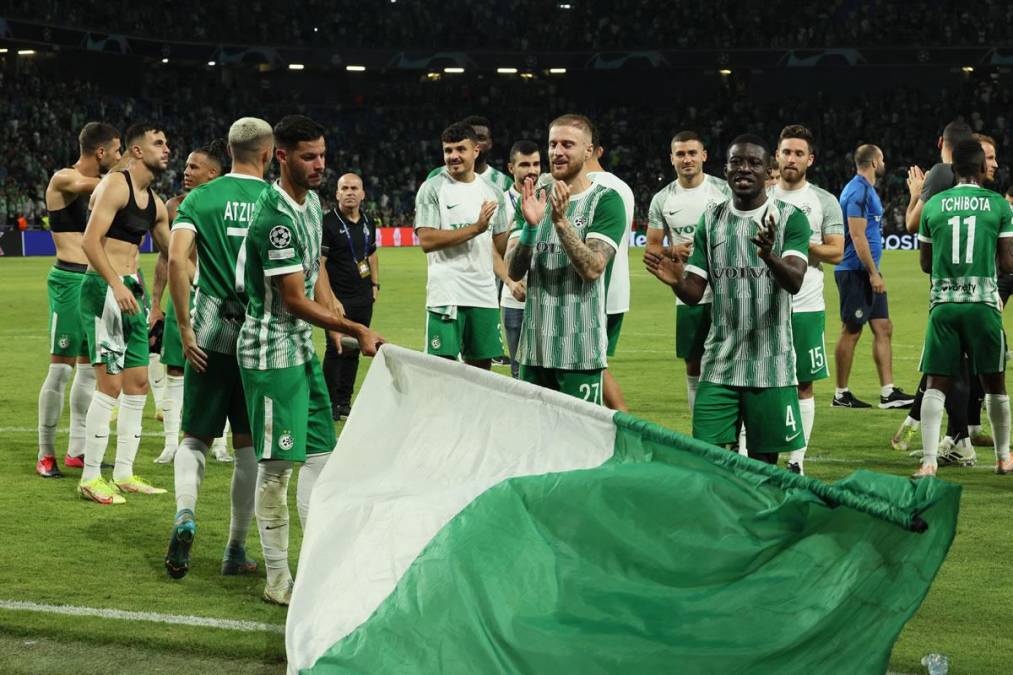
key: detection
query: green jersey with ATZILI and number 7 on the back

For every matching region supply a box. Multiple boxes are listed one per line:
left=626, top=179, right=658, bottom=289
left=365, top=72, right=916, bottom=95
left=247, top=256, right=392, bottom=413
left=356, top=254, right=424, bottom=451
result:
left=172, top=173, right=267, bottom=354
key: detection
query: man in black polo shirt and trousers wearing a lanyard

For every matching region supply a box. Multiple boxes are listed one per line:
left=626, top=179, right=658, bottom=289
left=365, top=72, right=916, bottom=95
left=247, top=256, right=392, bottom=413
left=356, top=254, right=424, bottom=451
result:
left=323, top=173, right=380, bottom=421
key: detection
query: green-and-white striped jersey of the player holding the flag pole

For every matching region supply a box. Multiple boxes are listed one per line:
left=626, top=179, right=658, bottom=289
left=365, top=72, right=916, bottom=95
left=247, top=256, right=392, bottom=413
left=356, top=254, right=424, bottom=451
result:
left=238, top=182, right=323, bottom=370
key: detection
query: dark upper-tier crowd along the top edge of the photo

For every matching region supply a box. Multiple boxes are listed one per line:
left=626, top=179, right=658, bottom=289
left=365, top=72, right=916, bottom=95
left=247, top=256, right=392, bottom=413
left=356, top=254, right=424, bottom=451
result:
left=4, top=0, right=1013, bottom=51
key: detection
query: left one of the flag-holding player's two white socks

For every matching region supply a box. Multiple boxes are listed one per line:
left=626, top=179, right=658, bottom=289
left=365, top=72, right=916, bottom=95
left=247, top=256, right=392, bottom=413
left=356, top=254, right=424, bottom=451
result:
left=254, top=459, right=292, bottom=587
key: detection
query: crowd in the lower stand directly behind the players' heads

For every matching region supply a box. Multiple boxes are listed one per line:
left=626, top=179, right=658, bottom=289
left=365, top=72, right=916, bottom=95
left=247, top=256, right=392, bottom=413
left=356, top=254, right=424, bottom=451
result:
left=0, top=60, right=1013, bottom=230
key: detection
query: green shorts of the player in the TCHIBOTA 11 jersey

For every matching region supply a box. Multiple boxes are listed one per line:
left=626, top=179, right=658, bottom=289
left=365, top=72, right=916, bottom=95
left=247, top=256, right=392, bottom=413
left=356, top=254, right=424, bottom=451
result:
left=918, top=302, right=1006, bottom=377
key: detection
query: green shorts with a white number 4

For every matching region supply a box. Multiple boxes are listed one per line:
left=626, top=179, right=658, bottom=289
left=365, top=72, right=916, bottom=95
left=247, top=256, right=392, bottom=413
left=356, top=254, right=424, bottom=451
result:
left=693, top=381, right=805, bottom=453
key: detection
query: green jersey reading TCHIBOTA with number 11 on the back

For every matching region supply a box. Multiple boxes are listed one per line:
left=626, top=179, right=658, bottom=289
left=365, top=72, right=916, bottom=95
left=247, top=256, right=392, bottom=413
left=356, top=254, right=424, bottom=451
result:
left=918, top=183, right=1013, bottom=311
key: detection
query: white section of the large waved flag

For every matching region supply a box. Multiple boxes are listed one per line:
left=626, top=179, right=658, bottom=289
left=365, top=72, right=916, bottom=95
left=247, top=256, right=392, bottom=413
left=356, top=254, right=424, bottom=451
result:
left=286, top=345, right=616, bottom=673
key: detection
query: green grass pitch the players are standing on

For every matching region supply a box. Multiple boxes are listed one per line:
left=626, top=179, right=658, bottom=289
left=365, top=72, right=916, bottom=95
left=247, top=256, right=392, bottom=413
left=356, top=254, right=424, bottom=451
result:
left=0, top=248, right=1013, bottom=674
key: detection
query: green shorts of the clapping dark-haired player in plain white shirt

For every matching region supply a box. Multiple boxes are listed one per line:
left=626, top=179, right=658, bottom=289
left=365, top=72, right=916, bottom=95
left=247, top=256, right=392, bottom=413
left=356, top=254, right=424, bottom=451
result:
left=425, top=307, right=503, bottom=361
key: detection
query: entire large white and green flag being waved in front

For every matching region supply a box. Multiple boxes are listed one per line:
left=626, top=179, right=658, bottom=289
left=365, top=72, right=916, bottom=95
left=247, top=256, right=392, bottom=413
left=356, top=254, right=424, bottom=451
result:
left=287, top=346, right=959, bottom=675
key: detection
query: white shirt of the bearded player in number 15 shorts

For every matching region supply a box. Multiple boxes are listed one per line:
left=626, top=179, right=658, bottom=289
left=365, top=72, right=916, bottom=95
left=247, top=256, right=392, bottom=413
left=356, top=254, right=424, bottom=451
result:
left=767, top=182, right=844, bottom=312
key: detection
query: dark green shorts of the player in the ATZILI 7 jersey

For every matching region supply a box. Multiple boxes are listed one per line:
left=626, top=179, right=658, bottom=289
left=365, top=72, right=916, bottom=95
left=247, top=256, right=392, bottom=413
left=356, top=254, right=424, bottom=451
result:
left=181, top=350, right=250, bottom=438
